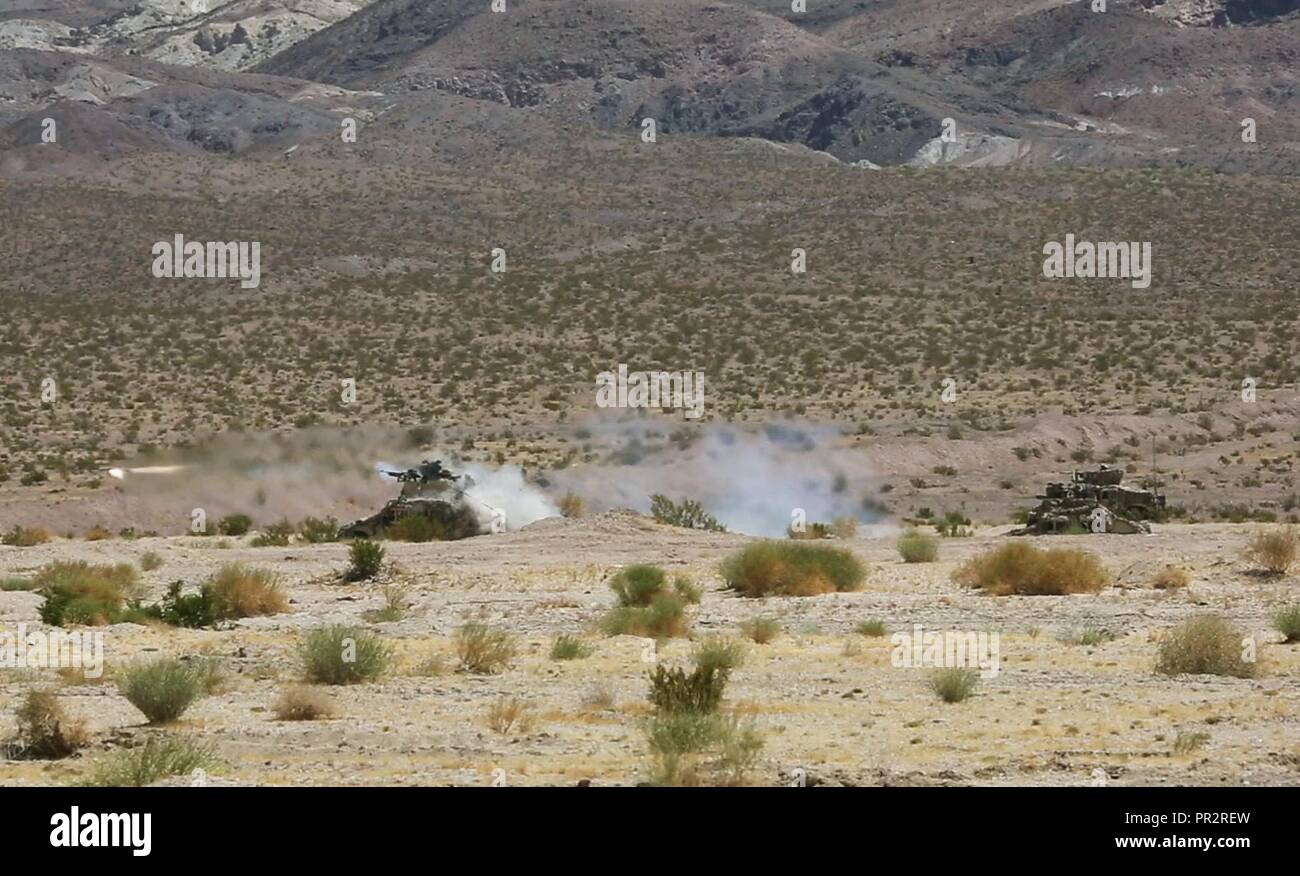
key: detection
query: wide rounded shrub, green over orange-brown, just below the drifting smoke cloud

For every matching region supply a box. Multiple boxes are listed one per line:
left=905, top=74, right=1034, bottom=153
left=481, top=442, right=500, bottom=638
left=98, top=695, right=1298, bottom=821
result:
left=722, top=541, right=867, bottom=597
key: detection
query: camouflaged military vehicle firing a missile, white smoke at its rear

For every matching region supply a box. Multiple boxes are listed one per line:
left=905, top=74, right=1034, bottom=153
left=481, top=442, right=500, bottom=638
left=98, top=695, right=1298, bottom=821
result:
left=338, top=459, right=504, bottom=541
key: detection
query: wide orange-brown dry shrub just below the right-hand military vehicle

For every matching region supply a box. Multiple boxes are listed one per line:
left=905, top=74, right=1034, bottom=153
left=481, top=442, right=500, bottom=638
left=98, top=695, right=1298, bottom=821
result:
left=953, top=541, right=1109, bottom=597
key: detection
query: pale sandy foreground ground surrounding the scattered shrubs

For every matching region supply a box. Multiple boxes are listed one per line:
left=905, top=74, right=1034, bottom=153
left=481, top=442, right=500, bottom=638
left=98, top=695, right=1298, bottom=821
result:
left=0, top=512, right=1300, bottom=785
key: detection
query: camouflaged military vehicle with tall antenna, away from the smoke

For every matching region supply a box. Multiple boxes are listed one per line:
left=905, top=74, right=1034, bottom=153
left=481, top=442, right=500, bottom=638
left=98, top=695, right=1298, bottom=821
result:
left=1011, top=465, right=1165, bottom=535
